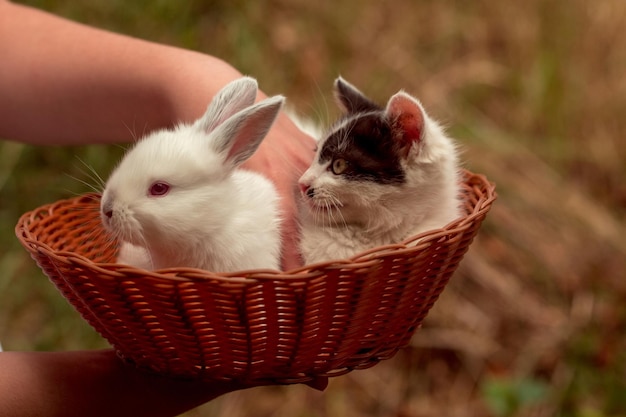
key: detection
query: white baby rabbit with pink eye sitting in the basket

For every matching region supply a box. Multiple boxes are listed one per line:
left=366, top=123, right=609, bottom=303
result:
left=100, top=77, right=284, bottom=272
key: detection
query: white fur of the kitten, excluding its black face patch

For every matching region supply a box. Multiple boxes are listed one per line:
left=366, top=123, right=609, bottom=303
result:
left=300, top=80, right=460, bottom=264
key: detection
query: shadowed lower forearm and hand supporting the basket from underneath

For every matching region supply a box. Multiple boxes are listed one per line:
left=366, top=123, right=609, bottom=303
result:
left=0, top=349, right=328, bottom=417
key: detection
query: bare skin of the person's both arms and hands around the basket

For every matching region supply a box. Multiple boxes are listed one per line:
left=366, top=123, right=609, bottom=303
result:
left=0, top=0, right=320, bottom=417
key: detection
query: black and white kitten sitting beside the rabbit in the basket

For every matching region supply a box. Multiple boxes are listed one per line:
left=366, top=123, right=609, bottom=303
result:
left=299, top=78, right=460, bottom=265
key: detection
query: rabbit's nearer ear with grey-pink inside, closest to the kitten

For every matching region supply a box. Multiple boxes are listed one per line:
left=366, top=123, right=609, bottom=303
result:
left=211, top=96, right=285, bottom=168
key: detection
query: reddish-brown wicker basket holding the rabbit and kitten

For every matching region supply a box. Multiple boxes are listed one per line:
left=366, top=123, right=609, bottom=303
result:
left=16, top=168, right=496, bottom=383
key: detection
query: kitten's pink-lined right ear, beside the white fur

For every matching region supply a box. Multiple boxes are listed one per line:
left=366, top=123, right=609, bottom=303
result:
left=385, top=91, right=424, bottom=155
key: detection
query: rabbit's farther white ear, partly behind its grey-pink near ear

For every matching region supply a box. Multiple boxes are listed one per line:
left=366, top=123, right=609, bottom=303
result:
left=196, top=77, right=258, bottom=133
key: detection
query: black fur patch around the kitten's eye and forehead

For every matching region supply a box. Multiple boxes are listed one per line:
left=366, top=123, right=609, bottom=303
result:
left=319, top=111, right=406, bottom=184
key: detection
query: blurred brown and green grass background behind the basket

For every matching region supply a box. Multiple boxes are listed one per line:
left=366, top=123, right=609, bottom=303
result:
left=0, top=0, right=626, bottom=417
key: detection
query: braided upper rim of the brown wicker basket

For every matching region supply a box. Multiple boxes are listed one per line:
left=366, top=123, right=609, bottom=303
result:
left=15, top=169, right=497, bottom=283
